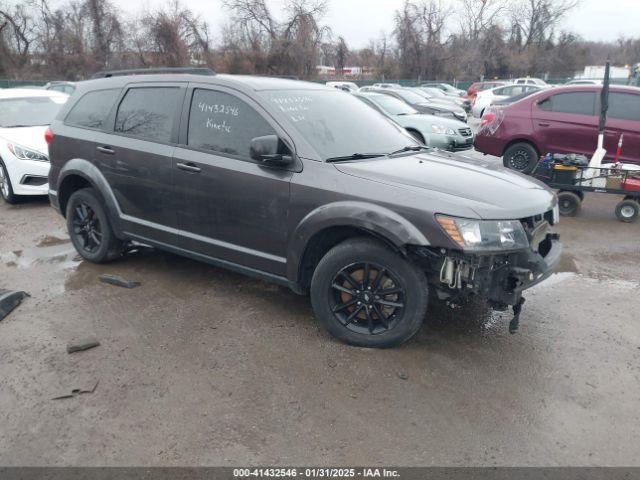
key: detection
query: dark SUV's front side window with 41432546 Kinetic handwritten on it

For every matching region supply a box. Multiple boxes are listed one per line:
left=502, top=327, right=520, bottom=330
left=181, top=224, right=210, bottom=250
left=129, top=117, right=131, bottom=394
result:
left=187, top=89, right=276, bottom=159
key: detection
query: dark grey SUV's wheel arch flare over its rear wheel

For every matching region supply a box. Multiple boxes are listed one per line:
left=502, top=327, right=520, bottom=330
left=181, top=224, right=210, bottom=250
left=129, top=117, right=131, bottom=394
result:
left=56, top=158, right=122, bottom=237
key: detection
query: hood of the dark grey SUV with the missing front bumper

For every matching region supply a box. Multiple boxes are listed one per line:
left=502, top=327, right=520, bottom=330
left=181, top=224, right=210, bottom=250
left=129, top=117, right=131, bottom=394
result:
left=334, top=152, right=556, bottom=220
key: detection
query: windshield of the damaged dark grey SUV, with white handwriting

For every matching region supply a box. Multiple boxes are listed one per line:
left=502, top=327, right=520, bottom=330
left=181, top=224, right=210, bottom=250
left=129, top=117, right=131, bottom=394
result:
left=261, top=90, right=415, bottom=160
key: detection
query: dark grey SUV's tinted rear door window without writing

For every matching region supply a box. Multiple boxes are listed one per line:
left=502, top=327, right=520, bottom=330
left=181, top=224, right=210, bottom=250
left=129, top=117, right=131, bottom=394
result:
left=115, top=87, right=180, bottom=143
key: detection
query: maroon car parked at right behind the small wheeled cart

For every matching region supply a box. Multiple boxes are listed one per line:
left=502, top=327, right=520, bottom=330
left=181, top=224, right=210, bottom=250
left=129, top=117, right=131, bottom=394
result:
left=475, top=85, right=640, bottom=173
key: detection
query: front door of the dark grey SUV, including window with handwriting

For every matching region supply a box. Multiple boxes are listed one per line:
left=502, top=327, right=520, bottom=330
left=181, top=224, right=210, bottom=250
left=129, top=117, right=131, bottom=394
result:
left=173, top=85, right=295, bottom=275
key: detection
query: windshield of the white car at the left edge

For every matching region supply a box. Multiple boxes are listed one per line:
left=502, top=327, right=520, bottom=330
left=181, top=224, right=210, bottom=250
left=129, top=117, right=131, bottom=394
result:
left=0, top=97, right=67, bottom=128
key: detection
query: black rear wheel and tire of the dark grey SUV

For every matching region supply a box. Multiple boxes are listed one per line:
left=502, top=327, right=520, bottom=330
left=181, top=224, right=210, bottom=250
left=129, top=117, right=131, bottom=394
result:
left=67, top=188, right=122, bottom=263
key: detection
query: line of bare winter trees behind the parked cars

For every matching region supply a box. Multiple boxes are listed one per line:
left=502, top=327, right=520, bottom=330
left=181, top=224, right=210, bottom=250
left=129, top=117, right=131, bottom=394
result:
left=0, top=0, right=640, bottom=80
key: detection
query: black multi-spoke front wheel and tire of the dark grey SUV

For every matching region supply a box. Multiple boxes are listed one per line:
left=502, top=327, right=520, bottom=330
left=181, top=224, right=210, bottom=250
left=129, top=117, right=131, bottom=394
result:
left=311, top=238, right=429, bottom=348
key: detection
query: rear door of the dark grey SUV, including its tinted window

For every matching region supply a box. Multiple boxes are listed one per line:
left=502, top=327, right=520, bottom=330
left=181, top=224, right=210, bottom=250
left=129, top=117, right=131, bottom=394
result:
left=96, top=83, right=186, bottom=237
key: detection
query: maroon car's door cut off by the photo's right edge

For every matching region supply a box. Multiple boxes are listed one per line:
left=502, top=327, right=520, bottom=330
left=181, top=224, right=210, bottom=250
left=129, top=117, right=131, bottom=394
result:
left=605, top=92, right=640, bottom=163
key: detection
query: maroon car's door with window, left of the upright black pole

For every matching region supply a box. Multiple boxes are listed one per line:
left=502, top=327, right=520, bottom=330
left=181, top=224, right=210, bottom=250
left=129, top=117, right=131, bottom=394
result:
left=531, top=91, right=598, bottom=157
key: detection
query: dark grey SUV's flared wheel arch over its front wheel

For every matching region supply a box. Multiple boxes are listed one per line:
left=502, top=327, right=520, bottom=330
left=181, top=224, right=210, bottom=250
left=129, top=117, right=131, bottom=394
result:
left=287, top=201, right=429, bottom=292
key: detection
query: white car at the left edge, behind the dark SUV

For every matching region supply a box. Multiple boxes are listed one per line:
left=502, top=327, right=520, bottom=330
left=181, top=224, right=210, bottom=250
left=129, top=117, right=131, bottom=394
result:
left=0, top=88, right=69, bottom=203
